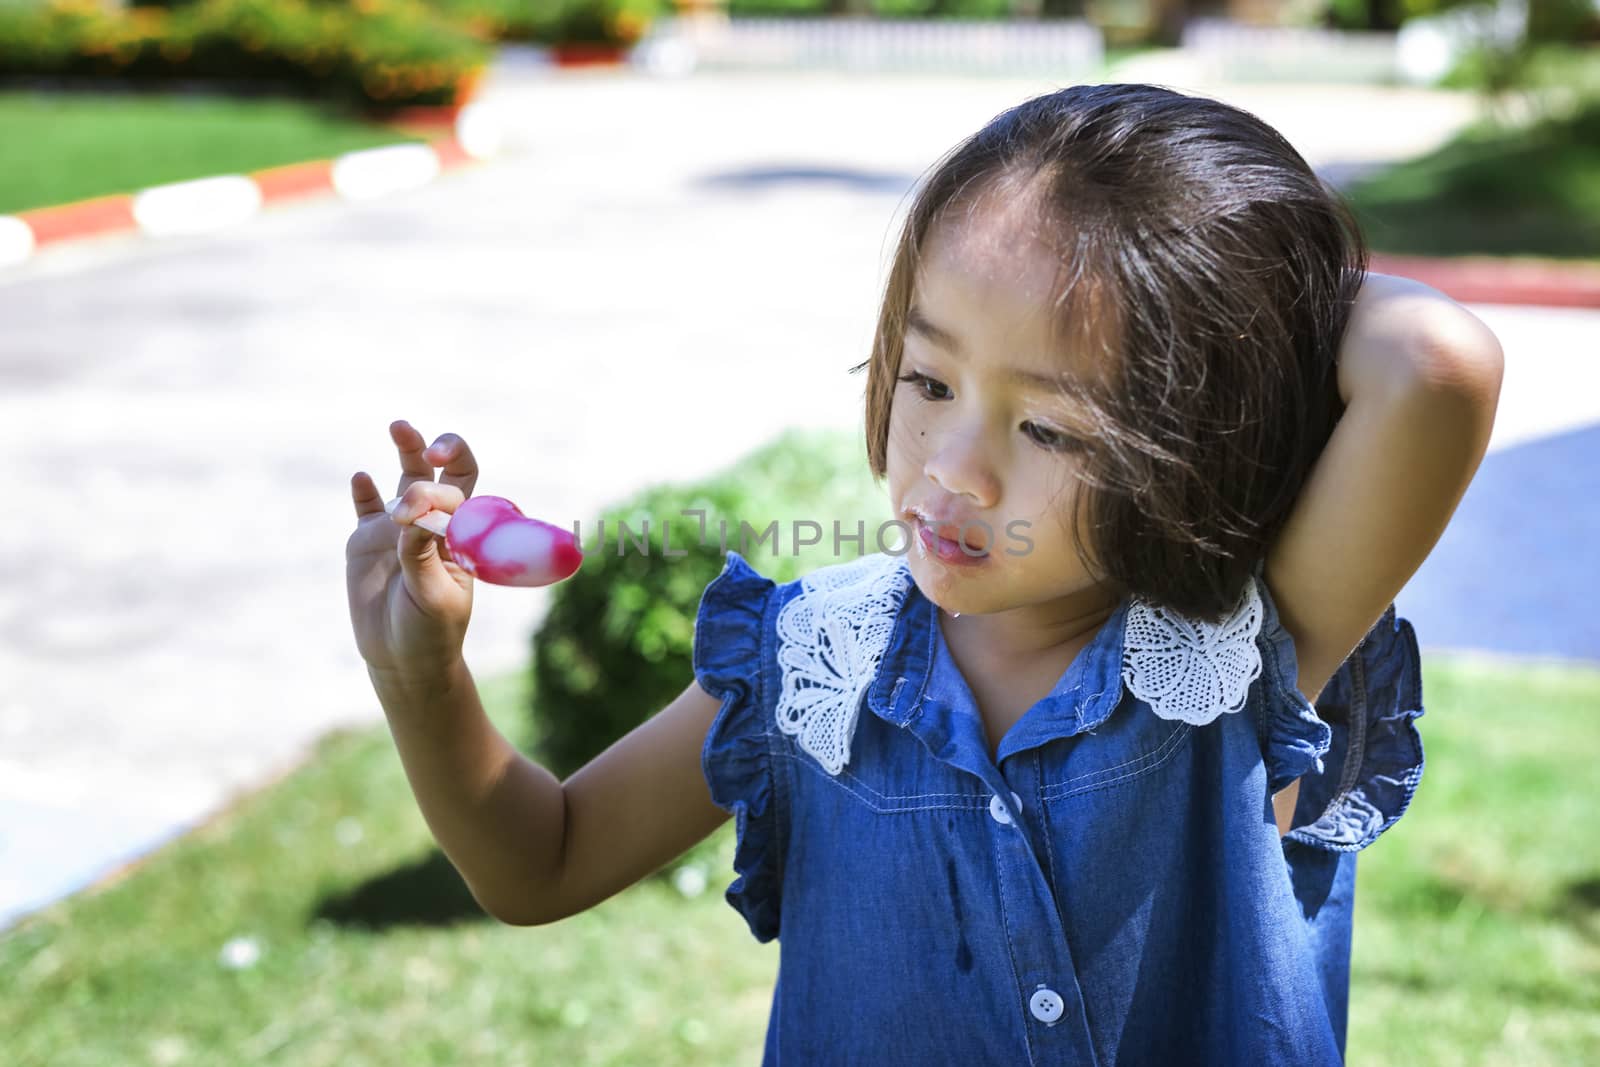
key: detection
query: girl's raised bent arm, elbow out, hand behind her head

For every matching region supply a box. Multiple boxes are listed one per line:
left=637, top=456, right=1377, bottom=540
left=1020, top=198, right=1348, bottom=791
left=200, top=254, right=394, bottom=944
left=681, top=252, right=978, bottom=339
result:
left=1266, top=274, right=1504, bottom=702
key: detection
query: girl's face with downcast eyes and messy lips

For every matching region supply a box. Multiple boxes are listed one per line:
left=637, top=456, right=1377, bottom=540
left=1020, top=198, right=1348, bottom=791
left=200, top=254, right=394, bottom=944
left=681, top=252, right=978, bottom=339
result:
left=886, top=205, right=1098, bottom=614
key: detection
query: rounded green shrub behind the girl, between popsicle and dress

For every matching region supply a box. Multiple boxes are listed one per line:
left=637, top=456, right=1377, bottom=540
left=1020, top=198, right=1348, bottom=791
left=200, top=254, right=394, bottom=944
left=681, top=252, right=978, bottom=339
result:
left=530, top=430, right=904, bottom=779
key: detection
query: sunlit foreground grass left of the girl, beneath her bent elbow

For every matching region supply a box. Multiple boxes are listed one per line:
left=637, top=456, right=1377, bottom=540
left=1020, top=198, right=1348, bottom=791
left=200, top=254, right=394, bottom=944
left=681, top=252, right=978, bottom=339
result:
left=0, top=668, right=778, bottom=1067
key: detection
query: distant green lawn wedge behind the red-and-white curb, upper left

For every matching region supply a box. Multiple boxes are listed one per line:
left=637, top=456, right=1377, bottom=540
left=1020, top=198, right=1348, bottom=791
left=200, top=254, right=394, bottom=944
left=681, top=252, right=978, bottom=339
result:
left=0, top=91, right=416, bottom=214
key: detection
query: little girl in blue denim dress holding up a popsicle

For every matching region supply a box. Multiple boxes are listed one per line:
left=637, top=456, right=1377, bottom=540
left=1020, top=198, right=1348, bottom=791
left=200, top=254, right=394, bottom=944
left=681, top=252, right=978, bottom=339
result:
left=347, top=85, right=1502, bottom=1067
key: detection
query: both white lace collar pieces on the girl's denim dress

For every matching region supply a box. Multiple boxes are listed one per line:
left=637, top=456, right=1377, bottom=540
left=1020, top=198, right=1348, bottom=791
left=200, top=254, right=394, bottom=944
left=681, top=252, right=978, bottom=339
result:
left=778, top=553, right=1264, bottom=774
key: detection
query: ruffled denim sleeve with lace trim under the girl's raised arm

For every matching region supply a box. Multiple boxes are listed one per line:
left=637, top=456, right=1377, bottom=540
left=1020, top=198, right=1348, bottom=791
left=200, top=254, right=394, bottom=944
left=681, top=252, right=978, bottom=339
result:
left=1258, top=568, right=1422, bottom=853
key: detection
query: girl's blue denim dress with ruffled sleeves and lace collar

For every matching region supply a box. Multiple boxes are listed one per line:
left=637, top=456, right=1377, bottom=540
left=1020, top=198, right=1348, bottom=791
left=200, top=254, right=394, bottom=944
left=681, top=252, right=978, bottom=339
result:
left=694, top=552, right=1422, bottom=1067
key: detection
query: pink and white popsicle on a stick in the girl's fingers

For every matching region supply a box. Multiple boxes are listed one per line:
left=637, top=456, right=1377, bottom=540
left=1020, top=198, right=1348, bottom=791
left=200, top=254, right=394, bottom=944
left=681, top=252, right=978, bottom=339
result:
left=389, top=496, right=584, bottom=585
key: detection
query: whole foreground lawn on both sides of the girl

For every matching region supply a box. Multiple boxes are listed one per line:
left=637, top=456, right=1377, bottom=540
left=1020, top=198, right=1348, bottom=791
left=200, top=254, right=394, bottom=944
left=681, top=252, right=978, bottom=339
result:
left=0, top=657, right=1600, bottom=1067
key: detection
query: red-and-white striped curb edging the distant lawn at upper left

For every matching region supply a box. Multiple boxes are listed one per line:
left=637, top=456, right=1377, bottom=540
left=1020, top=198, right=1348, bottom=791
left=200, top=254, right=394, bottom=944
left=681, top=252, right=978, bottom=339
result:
left=0, top=104, right=501, bottom=267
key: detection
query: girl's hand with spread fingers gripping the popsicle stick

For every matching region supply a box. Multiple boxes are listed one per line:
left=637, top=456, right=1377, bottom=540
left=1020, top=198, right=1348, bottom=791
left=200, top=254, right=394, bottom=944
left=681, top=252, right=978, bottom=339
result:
left=344, top=419, right=478, bottom=683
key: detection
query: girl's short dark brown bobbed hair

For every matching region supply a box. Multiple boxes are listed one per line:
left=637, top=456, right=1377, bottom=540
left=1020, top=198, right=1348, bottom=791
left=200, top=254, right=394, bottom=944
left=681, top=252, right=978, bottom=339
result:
left=853, top=85, right=1368, bottom=622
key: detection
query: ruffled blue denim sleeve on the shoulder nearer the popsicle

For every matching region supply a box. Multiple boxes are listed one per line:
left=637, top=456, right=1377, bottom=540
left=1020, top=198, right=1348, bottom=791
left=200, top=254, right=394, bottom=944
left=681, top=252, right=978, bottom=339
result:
left=694, top=552, right=786, bottom=942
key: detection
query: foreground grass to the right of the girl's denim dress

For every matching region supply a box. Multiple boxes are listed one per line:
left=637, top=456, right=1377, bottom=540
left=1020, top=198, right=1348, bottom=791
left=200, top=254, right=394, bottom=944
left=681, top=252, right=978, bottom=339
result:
left=1349, top=657, right=1600, bottom=1067
